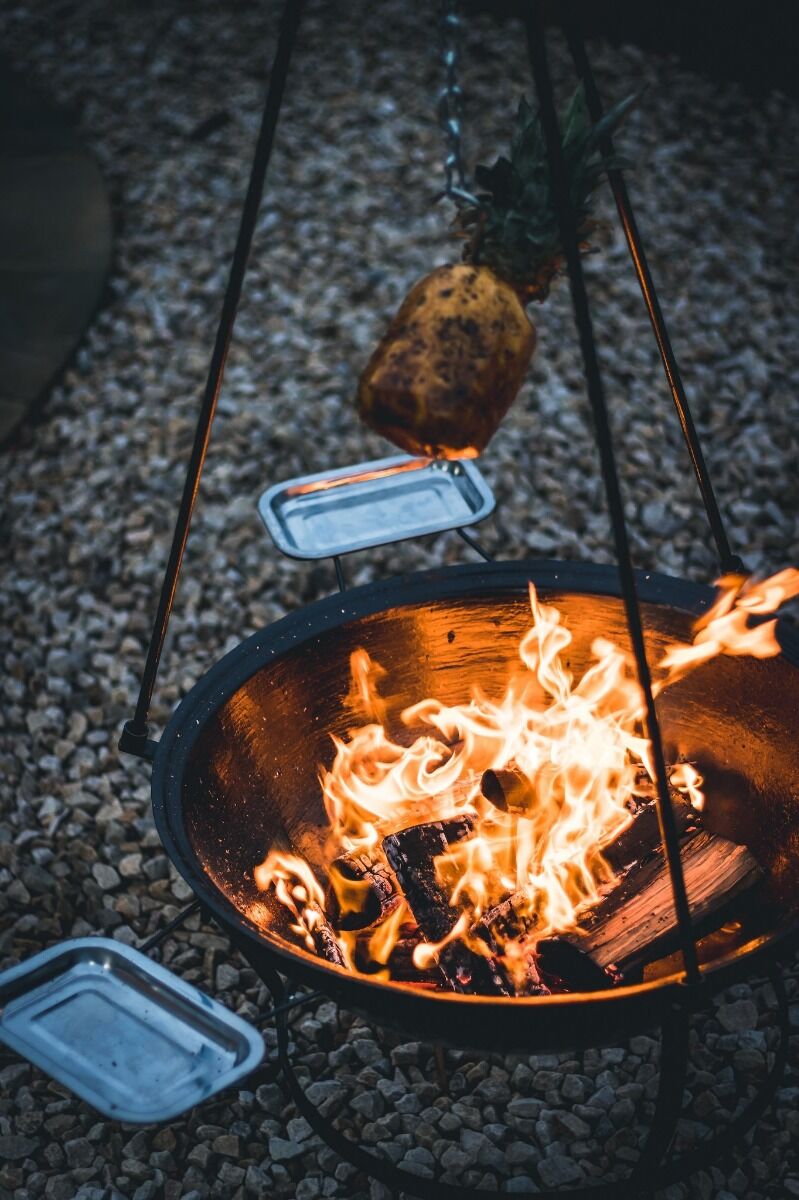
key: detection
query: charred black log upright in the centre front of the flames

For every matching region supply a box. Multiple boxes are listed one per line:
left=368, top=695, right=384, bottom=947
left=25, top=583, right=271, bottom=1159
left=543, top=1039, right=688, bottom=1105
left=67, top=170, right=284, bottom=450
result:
left=383, top=814, right=512, bottom=996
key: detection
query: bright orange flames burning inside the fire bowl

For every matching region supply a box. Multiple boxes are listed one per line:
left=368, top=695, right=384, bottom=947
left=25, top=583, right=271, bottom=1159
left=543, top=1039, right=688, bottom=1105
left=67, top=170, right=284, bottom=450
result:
left=254, top=569, right=799, bottom=977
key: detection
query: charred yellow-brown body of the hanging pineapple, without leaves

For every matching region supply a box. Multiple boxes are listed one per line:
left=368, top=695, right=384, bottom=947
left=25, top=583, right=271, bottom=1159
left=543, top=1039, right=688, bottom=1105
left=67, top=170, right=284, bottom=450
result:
left=356, top=263, right=536, bottom=458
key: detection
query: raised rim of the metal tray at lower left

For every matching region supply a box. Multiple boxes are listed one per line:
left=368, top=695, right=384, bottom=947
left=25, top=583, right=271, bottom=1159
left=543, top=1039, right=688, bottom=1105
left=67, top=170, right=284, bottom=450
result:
left=0, top=937, right=266, bottom=1124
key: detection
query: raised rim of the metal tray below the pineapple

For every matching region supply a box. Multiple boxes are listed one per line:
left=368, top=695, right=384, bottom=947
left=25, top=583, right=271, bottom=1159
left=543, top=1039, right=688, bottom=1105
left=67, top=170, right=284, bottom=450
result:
left=258, top=454, right=497, bottom=562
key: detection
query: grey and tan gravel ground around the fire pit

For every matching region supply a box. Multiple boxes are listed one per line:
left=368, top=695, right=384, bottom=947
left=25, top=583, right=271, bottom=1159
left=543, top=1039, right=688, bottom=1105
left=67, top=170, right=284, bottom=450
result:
left=0, top=0, right=799, bottom=1200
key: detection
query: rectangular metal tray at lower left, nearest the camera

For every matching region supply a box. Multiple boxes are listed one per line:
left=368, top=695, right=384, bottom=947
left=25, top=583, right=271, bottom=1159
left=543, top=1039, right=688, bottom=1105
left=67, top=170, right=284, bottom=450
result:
left=0, top=937, right=264, bottom=1123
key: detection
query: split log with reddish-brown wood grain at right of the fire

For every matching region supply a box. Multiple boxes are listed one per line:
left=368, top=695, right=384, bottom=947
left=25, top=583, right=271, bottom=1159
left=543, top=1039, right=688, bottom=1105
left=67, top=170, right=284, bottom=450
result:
left=537, top=829, right=763, bottom=991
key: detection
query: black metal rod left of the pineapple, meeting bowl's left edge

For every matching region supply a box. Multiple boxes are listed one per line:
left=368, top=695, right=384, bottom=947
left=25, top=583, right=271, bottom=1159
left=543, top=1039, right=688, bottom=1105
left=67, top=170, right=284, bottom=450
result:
left=120, top=0, right=304, bottom=750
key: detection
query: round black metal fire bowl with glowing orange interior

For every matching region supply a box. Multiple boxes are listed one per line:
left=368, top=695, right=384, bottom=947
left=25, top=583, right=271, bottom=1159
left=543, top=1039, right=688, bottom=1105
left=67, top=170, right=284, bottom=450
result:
left=152, top=562, right=799, bottom=1051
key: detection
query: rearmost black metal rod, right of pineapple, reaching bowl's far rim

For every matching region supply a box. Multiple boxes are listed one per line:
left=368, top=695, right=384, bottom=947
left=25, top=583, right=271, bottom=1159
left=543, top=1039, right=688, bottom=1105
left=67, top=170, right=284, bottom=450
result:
left=563, top=0, right=744, bottom=572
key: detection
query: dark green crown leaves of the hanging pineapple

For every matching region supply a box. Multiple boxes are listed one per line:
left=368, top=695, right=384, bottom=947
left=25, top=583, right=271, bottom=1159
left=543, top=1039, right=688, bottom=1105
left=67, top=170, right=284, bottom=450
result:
left=456, top=84, right=637, bottom=300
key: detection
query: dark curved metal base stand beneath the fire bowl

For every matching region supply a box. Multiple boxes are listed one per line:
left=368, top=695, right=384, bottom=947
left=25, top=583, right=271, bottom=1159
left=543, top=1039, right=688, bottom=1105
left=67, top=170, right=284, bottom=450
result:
left=251, top=946, right=791, bottom=1200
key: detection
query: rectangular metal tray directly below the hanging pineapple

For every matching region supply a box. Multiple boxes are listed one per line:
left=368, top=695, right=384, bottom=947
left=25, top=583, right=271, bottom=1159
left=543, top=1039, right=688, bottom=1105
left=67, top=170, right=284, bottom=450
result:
left=258, top=455, right=494, bottom=558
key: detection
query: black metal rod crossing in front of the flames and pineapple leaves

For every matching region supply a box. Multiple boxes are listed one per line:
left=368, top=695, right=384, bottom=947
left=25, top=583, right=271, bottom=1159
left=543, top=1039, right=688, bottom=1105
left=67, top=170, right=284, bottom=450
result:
left=523, top=7, right=699, bottom=984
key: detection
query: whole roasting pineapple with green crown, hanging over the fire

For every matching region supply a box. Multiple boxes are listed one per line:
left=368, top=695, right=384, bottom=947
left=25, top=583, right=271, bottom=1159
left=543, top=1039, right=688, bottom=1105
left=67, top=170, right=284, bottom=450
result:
left=356, top=86, right=635, bottom=458
